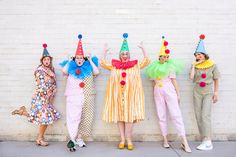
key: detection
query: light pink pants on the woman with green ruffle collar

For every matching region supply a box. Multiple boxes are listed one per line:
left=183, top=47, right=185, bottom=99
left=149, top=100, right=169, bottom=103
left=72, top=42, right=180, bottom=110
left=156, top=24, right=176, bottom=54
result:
left=154, top=82, right=185, bottom=136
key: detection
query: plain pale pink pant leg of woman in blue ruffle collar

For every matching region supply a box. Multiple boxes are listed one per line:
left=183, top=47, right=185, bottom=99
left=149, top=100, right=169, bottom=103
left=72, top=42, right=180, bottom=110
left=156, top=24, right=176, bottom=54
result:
left=66, top=94, right=84, bottom=140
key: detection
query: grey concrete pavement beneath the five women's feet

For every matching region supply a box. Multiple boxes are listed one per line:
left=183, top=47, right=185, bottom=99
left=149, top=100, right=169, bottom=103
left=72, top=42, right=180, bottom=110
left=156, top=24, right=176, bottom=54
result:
left=0, top=141, right=236, bottom=157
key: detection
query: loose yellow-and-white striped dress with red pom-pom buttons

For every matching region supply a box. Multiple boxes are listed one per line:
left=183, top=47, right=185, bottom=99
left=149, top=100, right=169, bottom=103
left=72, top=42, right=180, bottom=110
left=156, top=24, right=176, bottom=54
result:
left=101, top=57, right=150, bottom=123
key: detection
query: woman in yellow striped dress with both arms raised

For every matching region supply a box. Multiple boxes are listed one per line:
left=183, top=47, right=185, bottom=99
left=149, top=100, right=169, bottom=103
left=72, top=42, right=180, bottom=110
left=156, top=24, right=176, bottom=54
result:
left=101, top=33, right=150, bottom=150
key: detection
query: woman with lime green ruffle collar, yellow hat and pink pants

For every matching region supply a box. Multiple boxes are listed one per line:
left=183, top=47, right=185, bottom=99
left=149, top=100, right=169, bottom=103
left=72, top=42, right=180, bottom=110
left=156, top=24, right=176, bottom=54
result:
left=145, top=36, right=191, bottom=153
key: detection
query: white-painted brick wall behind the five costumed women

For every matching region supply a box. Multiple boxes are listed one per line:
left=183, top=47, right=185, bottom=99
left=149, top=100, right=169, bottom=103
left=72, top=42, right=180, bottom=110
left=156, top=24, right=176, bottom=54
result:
left=0, top=0, right=236, bottom=140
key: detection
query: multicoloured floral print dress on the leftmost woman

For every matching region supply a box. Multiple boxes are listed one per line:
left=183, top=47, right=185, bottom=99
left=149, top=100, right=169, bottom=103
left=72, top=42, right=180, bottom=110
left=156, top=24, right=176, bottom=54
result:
left=29, top=66, right=61, bottom=125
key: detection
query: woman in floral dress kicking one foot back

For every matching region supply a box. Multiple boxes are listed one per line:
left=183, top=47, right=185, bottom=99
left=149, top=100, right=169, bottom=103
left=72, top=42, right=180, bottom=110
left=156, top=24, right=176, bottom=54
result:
left=12, top=44, right=61, bottom=146
